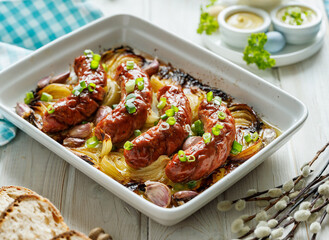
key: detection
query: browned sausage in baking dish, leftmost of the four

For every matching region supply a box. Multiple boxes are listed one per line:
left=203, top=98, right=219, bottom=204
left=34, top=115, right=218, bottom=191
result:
left=42, top=56, right=107, bottom=132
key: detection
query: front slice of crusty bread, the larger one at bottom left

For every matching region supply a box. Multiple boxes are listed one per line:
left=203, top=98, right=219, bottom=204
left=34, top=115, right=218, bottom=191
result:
left=0, top=195, right=69, bottom=240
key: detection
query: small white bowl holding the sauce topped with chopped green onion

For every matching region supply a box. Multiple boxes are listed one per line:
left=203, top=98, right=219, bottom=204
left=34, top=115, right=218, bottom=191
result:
left=271, top=3, right=322, bottom=45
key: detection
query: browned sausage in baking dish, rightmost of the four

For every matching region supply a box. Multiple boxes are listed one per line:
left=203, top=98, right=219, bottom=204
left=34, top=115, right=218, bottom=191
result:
left=166, top=100, right=235, bottom=182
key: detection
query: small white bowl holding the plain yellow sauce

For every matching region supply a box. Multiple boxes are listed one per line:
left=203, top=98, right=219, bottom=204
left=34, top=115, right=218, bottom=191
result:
left=218, top=5, right=271, bottom=48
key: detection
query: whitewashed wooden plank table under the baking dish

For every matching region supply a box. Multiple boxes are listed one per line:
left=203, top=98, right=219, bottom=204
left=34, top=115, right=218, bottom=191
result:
left=0, top=0, right=329, bottom=240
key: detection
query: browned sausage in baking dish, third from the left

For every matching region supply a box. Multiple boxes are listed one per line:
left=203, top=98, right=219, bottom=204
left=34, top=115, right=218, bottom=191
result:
left=124, top=86, right=192, bottom=168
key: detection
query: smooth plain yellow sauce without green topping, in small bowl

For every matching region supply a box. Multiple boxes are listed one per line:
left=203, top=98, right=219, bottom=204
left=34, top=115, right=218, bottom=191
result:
left=226, top=12, right=264, bottom=29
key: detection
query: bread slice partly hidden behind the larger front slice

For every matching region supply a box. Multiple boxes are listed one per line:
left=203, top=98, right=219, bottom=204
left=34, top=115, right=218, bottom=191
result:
left=0, top=186, right=37, bottom=214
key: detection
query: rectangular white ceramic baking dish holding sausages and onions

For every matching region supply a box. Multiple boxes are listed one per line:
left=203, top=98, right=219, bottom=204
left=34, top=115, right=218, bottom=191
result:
left=0, top=15, right=307, bottom=225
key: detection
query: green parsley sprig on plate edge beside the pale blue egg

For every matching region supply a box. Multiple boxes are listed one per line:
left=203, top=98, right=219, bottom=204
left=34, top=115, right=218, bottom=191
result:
left=243, top=33, right=275, bottom=70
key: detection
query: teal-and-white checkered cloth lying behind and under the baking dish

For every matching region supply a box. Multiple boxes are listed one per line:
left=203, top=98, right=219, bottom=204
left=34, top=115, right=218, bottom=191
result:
left=0, top=0, right=102, bottom=146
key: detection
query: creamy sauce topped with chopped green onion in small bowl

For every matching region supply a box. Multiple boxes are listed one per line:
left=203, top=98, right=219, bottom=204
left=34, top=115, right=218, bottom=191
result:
left=277, top=6, right=316, bottom=26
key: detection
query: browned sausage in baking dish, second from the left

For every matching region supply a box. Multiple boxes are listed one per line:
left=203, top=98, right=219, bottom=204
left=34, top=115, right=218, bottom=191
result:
left=95, top=63, right=152, bottom=143
